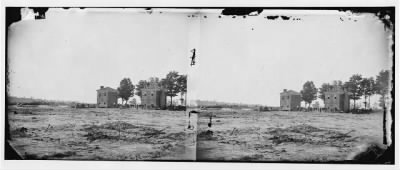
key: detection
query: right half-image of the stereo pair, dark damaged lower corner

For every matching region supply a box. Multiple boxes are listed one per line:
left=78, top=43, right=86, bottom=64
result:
left=188, top=8, right=394, bottom=163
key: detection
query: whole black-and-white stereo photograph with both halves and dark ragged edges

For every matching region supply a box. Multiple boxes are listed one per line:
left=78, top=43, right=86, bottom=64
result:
left=5, top=7, right=395, bottom=164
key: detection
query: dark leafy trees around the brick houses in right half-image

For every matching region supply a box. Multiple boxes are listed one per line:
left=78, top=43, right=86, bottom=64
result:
left=300, top=70, right=390, bottom=109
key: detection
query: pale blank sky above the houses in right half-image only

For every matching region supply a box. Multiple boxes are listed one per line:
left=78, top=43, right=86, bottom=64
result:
left=188, top=11, right=391, bottom=106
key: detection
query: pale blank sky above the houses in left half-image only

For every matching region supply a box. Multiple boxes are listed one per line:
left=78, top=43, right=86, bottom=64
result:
left=8, top=8, right=191, bottom=103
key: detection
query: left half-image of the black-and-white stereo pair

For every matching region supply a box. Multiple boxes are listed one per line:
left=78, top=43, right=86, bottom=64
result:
left=6, top=8, right=196, bottom=160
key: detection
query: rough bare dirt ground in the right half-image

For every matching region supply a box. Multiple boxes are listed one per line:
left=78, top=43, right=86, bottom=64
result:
left=196, top=109, right=383, bottom=162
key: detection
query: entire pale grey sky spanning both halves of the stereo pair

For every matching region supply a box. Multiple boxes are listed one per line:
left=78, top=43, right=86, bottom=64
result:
left=8, top=9, right=391, bottom=106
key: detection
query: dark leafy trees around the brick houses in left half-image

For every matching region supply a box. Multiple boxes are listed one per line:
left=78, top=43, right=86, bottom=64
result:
left=117, top=71, right=187, bottom=106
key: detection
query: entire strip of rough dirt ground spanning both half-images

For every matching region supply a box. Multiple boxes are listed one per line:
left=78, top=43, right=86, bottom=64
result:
left=8, top=106, right=383, bottom=162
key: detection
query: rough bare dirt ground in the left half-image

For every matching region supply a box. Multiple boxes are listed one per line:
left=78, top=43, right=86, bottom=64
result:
left=8, top=106, right=197, bottom=160
